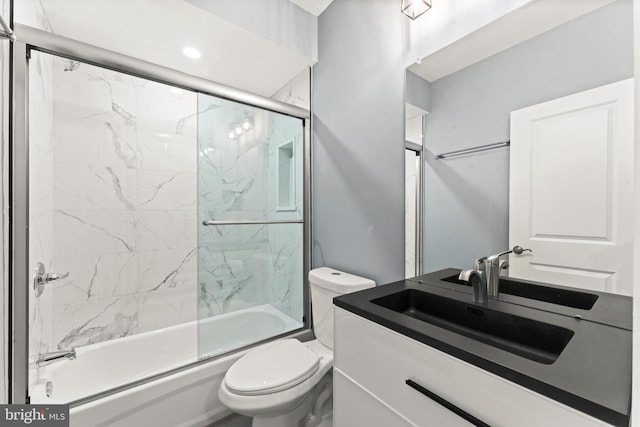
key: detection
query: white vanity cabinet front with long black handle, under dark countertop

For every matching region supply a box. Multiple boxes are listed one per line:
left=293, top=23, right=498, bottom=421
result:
left=334, top=307, right=609, bottom=427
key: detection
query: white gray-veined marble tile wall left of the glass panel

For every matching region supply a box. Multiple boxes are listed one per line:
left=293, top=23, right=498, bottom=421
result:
left=30, top=53, right=197, bottom=354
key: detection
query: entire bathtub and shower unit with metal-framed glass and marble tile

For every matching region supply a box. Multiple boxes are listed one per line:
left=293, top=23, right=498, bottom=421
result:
left=10, top=25, right=310, bottom=426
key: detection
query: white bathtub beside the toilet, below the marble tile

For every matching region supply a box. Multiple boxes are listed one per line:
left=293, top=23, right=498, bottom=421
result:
left=31, top=305, right=302, bottom=427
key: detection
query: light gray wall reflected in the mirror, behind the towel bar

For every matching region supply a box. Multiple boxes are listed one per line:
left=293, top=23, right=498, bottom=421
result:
left=424, top=0, right=633, bottom=272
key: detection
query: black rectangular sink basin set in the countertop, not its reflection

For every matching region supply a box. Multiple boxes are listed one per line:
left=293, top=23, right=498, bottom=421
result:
left=371, top=289, right=573, bottom=364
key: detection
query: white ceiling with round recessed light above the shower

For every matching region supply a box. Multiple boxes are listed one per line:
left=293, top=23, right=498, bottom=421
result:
left=33, top=0, right=316, bottom=96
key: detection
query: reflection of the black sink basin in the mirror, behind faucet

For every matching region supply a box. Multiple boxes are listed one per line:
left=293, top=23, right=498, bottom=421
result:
left=442, top=275, right=598, bottom=310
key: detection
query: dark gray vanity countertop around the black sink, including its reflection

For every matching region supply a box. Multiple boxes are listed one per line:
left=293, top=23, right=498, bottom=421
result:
left=334, top=269, right=632, bottom=426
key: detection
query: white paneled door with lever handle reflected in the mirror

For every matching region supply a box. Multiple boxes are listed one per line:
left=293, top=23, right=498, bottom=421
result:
left=509, top=79, right=634, bottom=295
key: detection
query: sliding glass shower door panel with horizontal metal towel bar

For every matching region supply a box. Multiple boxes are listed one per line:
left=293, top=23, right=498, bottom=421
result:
left=198, top=94, right=304, bottom=358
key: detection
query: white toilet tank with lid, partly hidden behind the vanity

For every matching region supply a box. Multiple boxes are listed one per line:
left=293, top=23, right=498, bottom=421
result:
left=309, top=267, right=376, bottom=349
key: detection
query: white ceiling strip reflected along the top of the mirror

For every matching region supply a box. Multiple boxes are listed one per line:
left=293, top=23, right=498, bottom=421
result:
left=409, top=0, right=614, bottom=82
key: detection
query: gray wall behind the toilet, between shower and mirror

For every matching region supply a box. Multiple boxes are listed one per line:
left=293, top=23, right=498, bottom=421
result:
left=312, top=0, right=406, bottom=284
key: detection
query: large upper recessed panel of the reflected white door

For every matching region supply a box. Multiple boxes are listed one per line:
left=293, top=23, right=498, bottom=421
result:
left=530, top=104, right=614, bottom=240
